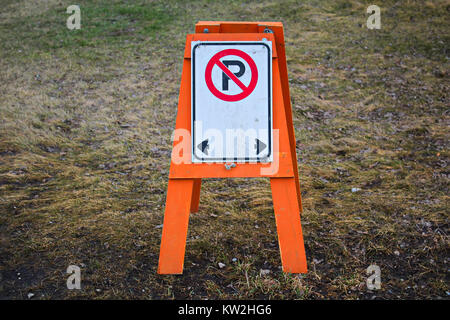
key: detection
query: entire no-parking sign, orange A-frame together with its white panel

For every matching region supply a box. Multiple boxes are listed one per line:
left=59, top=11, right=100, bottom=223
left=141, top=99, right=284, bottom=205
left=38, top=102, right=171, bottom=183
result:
left=158, top=21, right=307, bottom=274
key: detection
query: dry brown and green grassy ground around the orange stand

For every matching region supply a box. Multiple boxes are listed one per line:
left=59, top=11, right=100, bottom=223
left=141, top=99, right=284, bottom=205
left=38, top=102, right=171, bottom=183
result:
left=0, top=0, right=450, bottom=299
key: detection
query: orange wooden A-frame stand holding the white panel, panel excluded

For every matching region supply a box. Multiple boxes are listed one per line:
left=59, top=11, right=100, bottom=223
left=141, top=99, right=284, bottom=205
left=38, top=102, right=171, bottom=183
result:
left=158, top=21, right=307, bottom=274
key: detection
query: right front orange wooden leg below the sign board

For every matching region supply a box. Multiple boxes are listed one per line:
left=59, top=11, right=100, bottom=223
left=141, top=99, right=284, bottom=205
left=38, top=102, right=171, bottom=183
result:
left=270, top=177, right=307, bottom=273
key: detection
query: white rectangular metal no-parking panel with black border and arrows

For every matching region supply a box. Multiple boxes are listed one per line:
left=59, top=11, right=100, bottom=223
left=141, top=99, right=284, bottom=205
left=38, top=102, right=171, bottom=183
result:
left=191, top=41, right=273, bottom=163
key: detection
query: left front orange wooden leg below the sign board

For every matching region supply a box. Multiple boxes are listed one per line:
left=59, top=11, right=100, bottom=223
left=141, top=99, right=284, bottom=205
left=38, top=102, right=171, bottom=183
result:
left=158, top=179, right=194, bottom=274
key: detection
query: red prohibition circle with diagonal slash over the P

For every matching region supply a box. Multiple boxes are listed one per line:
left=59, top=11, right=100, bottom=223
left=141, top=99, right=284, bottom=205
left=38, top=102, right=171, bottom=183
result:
left=205, top=49, right=258, bottom=102
